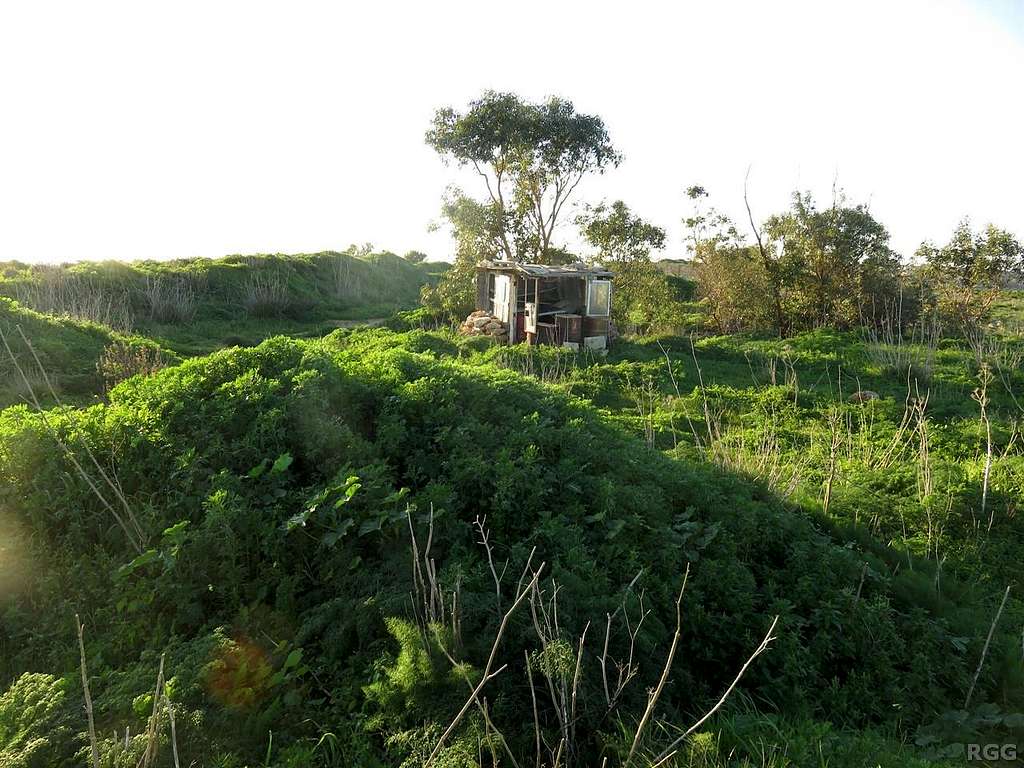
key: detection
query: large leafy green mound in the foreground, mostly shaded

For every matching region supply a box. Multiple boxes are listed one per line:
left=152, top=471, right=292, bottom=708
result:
left=0, top=331, right=1020, bottom=766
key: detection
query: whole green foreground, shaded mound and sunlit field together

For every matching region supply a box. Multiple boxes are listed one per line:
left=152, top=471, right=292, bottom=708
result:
left=0, top=330, right=1024, bottom=768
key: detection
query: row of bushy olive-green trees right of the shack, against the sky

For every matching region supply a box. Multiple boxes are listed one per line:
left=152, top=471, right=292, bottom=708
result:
left=684, top=186, right=1024, bottom=337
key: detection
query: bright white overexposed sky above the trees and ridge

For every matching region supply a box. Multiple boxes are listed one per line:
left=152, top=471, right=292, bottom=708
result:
left=0, top=0, right=1024, bottom=261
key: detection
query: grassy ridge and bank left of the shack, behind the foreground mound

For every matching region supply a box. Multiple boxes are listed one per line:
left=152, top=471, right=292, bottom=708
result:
left=0, top=252, right=446, bottom=409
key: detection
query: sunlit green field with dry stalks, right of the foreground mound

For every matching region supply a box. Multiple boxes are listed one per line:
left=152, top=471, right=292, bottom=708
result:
left=478, top=331, right=1024, bottom=589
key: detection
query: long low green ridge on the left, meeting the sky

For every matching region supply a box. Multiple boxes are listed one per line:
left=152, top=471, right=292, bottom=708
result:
left=0, top=250, right=446, bottom=355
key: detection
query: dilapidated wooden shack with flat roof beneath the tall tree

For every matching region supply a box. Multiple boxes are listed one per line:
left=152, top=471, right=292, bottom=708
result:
left=467, top=261, right=613, bottom=350
